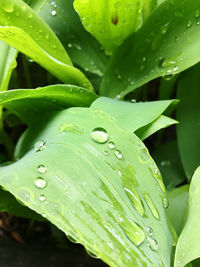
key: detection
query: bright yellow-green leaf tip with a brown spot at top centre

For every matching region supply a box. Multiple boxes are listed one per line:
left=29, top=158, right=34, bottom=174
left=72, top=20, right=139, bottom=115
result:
left=74, top=0, right=144, bottom=54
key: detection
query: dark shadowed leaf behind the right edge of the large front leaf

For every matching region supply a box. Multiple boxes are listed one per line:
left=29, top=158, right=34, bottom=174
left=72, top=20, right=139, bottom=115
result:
left=152, top=140, right=186, bottom=188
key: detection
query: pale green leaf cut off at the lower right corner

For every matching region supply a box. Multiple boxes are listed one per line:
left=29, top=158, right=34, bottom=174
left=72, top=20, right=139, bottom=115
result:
left=175, top=168, right=200, bottom=267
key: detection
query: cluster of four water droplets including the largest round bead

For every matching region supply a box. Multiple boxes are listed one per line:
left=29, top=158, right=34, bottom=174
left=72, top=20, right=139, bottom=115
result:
left=91, top=127, right=123, bottom=160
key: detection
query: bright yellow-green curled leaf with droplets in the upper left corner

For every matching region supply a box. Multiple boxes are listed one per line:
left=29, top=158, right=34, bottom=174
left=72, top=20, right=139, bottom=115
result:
left=0, top=0, right=92, bottom=89
